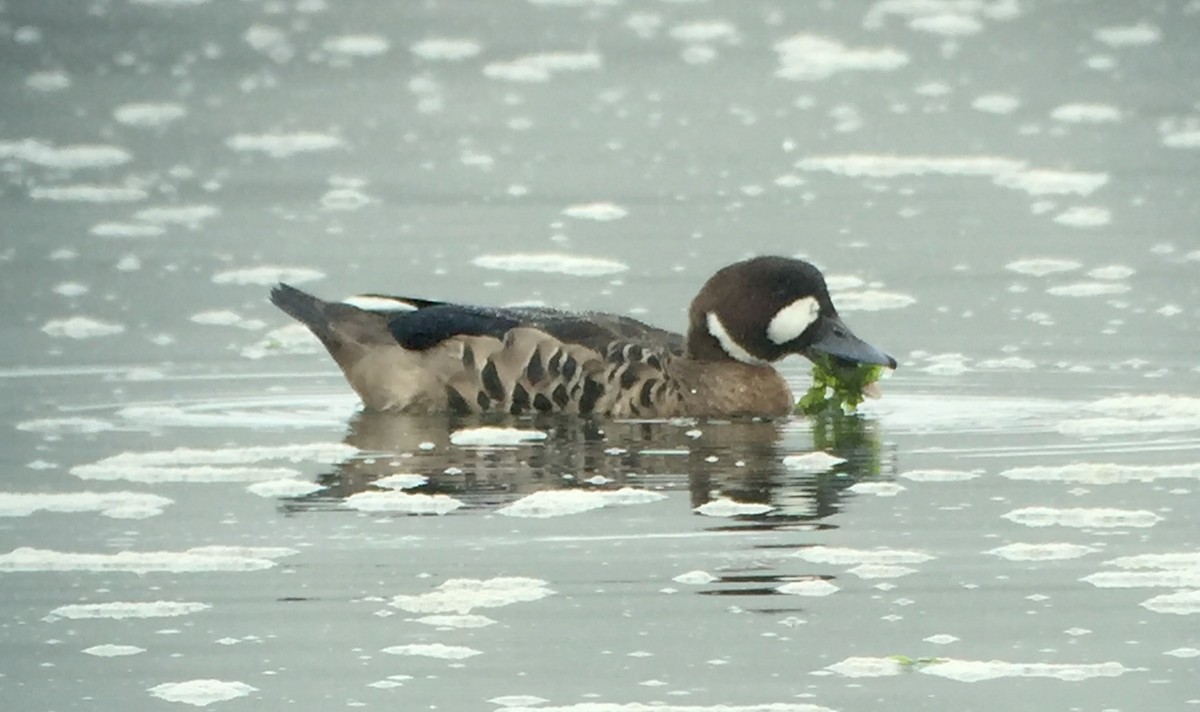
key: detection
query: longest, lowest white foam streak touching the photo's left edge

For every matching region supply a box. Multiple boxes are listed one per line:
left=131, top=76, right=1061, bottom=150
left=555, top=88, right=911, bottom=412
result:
left=0, top=546, right=296, bottom=574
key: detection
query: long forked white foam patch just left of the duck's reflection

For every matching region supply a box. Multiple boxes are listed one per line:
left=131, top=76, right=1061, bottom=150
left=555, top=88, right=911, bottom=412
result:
left=71, top=443, right=358, bottom=483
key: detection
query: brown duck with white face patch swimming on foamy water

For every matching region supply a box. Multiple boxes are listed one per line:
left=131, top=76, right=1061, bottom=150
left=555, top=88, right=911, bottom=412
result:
left=270, top=256, right=896, bottom=419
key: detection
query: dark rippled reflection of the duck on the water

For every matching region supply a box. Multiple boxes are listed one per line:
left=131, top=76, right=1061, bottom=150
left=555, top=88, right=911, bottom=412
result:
left=283, top=412, right=893, bottom=529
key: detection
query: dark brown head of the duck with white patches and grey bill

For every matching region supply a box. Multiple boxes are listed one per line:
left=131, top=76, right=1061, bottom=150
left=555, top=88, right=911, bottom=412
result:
left=688, top=257, right=896, bottom=369
